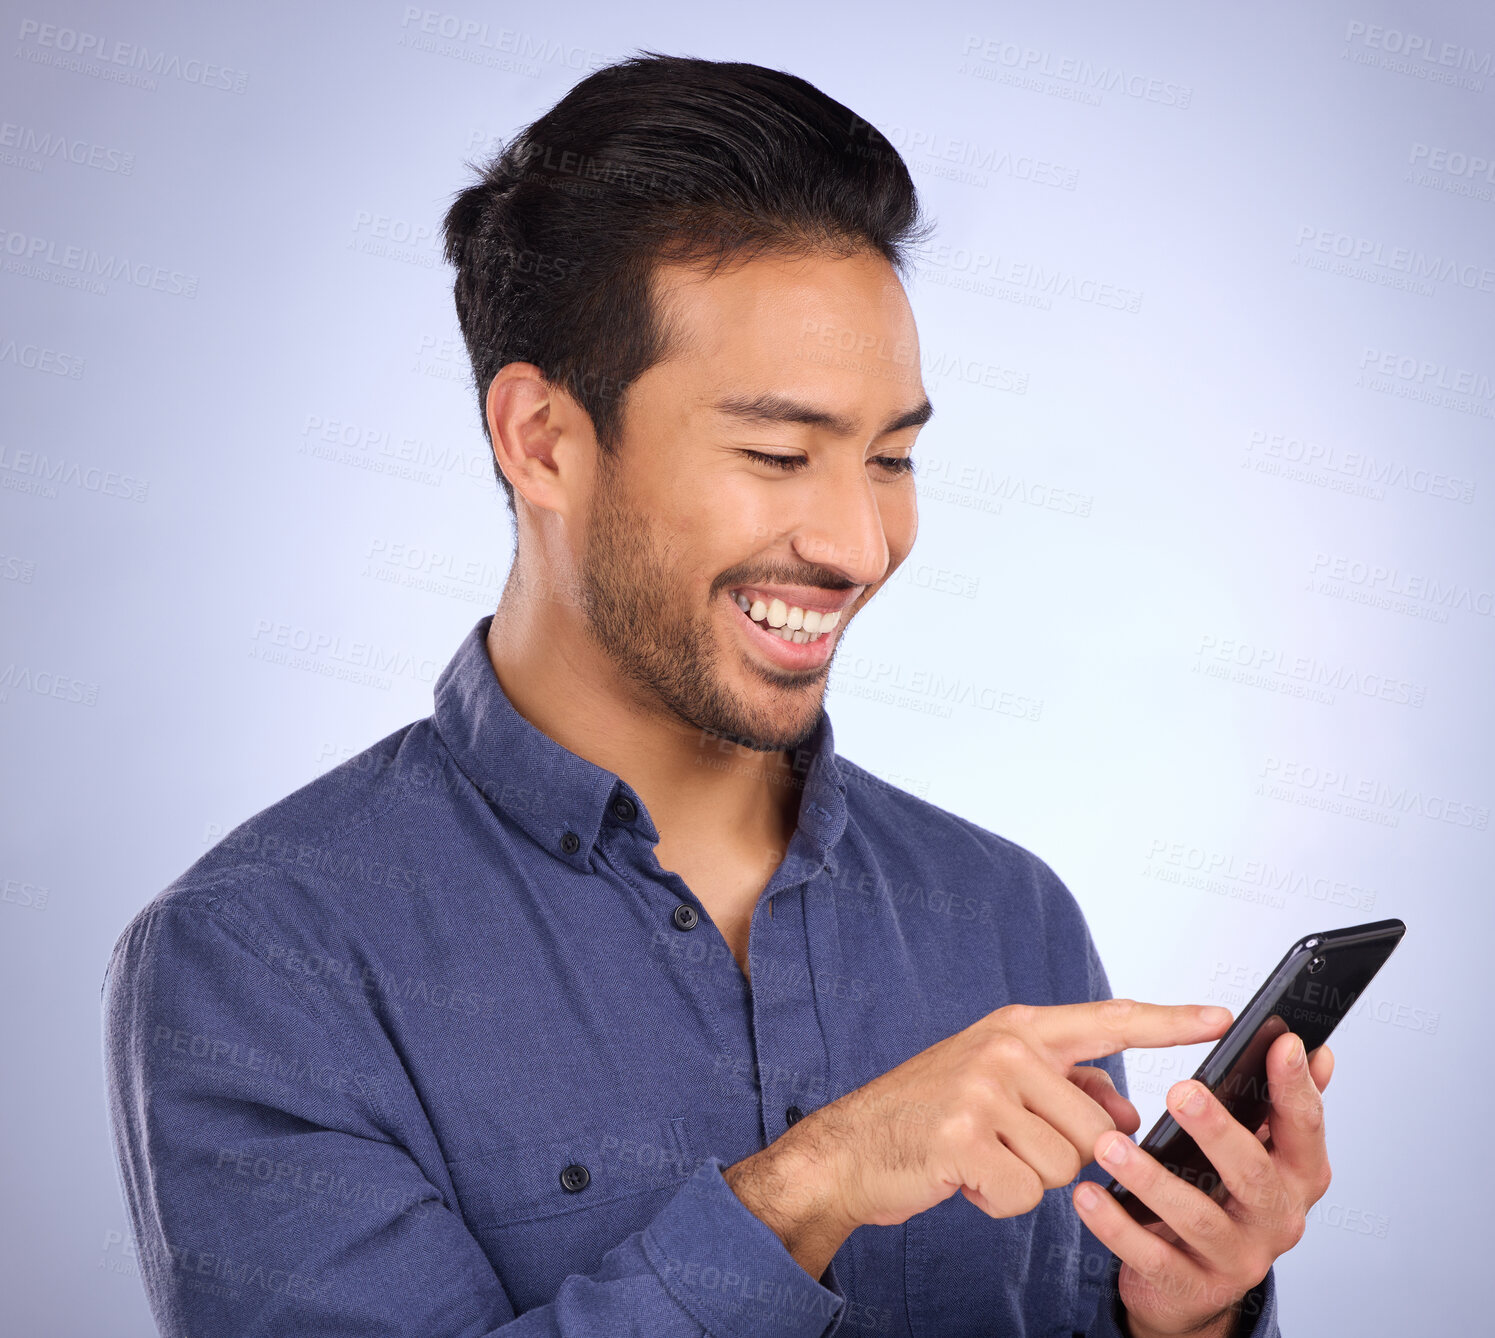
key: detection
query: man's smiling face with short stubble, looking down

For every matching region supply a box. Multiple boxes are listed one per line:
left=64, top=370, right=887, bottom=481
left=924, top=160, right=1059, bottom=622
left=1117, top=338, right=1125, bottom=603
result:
left=579, top=246, right=925, bottom=750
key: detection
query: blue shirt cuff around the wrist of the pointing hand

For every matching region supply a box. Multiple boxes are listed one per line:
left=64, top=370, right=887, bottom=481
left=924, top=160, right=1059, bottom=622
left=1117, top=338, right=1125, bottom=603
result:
left=643, top=1156, right=846, bottom=1338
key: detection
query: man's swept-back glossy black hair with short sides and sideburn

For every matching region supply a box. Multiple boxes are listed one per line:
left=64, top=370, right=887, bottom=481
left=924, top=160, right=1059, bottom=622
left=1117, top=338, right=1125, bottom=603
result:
left=443, top=51, right=931, bottom=513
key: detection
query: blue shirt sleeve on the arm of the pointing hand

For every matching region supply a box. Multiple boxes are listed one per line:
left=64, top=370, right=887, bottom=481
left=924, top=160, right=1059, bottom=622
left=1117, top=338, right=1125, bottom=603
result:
left=103, top=900, right=845, bottom=1338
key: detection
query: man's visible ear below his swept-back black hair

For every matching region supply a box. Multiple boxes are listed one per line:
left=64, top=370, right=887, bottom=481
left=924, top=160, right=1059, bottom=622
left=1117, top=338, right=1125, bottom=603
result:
left=484, top=362, right=586, bottom=514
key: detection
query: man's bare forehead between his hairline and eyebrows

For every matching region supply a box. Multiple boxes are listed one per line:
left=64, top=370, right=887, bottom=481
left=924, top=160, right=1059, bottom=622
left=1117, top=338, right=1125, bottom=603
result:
left=655, top=251, right=922, bottom=408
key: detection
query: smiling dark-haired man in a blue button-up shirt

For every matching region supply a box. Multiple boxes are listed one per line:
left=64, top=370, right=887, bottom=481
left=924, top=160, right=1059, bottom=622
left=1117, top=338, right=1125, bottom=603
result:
left=106, top=54, right=1332, bottom=1338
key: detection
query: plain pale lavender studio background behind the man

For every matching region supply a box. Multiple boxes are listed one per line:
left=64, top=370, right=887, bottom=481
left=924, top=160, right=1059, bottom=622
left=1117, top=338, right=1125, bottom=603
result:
left=0, top=0, right=1495, bottom=1335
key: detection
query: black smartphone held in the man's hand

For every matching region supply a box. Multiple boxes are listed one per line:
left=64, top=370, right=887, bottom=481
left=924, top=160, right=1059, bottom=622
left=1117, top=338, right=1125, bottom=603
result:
left=1106, top=919, right=1407, bottom=1226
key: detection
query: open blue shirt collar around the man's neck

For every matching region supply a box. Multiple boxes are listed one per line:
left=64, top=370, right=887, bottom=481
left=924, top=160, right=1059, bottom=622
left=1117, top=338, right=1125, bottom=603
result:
left=434, top=613, right=846, bottom=873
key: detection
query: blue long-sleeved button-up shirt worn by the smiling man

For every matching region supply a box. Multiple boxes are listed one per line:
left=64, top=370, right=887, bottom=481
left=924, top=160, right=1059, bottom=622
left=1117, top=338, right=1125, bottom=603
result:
left=105, top=616, right=1278, bottom=1338
